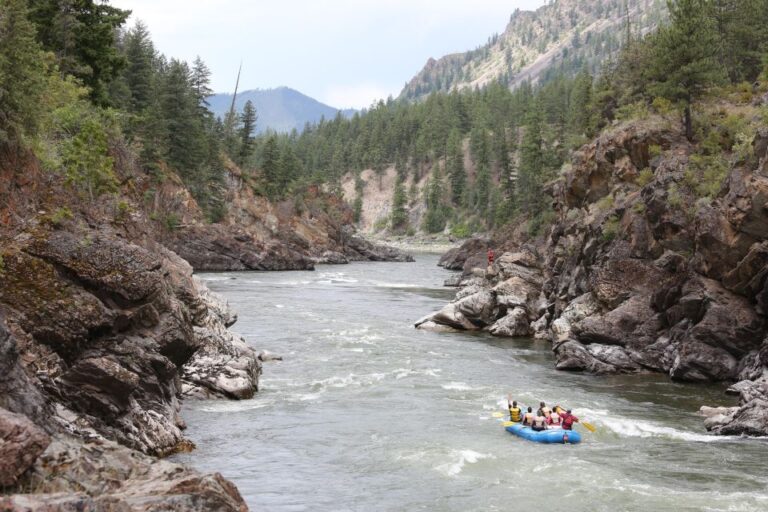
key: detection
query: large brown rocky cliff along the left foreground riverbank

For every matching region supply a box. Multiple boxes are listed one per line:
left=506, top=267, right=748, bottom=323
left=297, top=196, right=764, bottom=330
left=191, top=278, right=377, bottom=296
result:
left=0, top=149, right=261, bottom=510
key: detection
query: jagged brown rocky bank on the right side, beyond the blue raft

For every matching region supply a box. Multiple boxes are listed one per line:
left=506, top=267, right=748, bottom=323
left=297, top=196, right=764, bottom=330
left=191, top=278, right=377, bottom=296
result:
left=416, top=118, right=768, bottom=435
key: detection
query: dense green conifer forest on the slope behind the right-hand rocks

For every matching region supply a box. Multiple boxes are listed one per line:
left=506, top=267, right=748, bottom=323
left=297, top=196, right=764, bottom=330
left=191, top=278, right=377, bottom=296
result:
left=244, top=0, right=766, bottom=239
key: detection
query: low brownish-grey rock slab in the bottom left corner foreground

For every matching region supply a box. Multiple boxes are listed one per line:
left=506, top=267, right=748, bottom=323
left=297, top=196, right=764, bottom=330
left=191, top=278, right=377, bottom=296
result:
left=0, top=436, right=248, bottom=512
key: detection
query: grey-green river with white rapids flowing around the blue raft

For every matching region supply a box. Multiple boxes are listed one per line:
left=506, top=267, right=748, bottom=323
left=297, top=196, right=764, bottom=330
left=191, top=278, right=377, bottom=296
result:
left=176, top=255, right=768, bottom=512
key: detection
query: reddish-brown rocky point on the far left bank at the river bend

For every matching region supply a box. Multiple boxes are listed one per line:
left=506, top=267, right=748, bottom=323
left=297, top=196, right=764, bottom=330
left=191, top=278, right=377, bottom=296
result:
left=160, top=170, right=413, bottom=271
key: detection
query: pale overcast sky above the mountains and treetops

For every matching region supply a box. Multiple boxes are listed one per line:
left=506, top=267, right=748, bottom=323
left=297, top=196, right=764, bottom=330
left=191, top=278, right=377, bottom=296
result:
left=110, top=0, right=544, bottom=108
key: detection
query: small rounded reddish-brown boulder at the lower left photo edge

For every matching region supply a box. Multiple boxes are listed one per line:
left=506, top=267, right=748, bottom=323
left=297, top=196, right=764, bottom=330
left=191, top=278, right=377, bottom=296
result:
left=0, top=409, right=51, bottom=487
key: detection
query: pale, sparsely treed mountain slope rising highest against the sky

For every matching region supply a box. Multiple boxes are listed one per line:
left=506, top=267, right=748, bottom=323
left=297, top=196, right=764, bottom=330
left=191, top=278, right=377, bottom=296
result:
left=400, top=0, right=667, bottom=100
